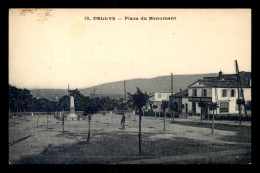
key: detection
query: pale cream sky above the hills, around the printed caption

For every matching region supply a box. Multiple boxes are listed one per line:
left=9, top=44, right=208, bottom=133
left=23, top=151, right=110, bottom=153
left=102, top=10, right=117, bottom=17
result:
left=9, top=9, right=251, bottom=89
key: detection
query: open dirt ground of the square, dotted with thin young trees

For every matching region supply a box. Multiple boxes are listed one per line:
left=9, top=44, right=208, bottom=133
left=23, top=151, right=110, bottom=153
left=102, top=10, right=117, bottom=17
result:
left=9, top=114, right=251, bottom=164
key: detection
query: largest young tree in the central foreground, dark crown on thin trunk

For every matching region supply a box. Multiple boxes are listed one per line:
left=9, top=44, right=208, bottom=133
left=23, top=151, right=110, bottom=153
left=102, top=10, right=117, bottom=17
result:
left=129, top=87, right=149, bottom=154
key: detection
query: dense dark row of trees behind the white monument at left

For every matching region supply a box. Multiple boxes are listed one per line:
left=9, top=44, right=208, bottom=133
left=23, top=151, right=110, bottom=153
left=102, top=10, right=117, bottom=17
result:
left=9, top=85, right=133, bottom=113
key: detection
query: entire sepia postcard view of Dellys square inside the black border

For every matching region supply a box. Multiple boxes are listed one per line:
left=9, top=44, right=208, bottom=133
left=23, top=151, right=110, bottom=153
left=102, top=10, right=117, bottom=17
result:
left=8, top=8, right=252, bottom=165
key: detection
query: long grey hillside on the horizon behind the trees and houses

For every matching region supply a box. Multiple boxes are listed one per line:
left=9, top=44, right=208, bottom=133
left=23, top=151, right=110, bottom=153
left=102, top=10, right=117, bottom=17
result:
left=31, top=73, right=218, bottom=100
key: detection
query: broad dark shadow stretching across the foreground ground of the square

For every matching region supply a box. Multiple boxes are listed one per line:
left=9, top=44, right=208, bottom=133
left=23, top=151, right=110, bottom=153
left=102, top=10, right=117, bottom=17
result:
left=18, top=132, right=250, bottom=164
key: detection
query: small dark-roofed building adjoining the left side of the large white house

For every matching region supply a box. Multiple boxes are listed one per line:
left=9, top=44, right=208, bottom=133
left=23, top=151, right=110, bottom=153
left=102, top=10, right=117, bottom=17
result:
left=172, top=89, right=192, bottom=114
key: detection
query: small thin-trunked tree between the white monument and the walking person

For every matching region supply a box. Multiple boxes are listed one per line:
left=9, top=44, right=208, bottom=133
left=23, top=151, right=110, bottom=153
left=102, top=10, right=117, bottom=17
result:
left=83, top=98, right=98, bottom=142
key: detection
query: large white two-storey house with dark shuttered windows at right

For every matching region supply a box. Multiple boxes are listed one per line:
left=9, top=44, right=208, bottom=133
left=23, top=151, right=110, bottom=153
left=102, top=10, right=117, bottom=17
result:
left=188, top=71, right=251, bottom=114
